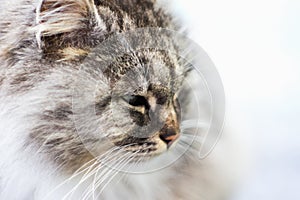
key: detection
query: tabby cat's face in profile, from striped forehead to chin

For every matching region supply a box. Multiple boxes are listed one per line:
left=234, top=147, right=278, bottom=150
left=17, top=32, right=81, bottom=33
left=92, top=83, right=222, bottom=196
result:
left=73, top=50, right=187, bottom=163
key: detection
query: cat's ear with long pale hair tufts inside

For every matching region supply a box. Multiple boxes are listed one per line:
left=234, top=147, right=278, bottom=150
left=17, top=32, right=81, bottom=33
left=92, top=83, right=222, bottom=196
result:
left=36, top=0, right=104, bottom=57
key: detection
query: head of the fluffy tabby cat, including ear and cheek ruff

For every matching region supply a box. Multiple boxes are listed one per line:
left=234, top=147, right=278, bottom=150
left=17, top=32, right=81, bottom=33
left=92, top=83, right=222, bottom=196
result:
left=28, top=0, right=197, bottom=171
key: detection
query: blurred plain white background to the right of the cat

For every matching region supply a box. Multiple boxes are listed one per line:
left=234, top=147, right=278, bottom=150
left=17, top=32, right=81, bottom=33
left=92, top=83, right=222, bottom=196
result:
left=174, top=0, right=300, bottom=200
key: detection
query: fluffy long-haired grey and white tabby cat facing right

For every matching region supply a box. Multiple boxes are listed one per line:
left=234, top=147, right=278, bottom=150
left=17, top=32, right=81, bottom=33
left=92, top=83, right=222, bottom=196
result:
left=0, top=0, right=240, bottom=200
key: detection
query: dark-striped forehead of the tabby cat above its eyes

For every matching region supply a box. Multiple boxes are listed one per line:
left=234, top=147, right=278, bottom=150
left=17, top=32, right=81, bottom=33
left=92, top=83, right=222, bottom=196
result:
left=109, top=50, right=185, bottom=93
